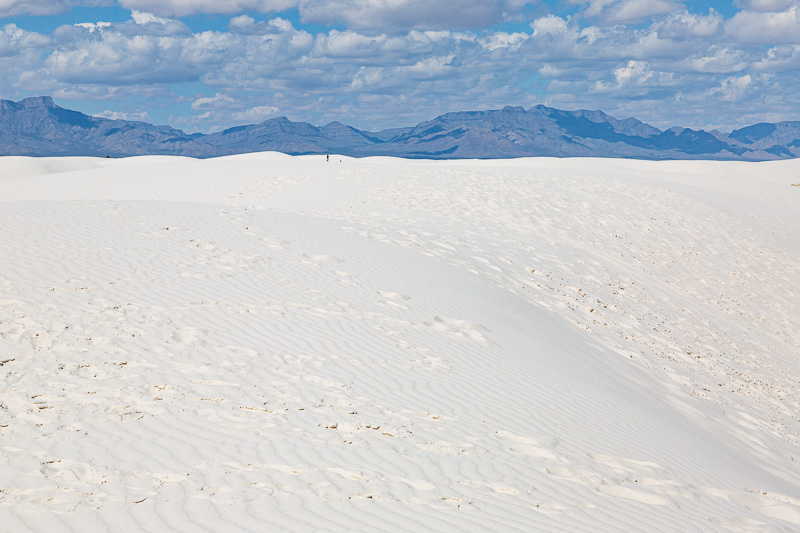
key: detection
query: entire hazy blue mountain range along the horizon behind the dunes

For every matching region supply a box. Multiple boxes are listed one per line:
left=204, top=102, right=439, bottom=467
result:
left=0, top=96, right=800, bottom=161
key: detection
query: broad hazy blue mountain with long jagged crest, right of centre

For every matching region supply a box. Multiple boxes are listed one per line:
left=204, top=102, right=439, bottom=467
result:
left=346, top=105, right=772, bottom=159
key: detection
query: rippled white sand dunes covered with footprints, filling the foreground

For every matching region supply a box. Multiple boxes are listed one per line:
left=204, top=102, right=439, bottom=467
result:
left=0, top=153, right=800, bottom=533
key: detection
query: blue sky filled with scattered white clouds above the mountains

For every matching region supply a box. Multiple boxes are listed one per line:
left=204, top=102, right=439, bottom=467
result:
left=0, top=0, right=800, bottom=133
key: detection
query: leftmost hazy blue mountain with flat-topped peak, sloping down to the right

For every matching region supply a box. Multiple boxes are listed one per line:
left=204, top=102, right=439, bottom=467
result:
left=0, top=96, right=232, bottom=157
